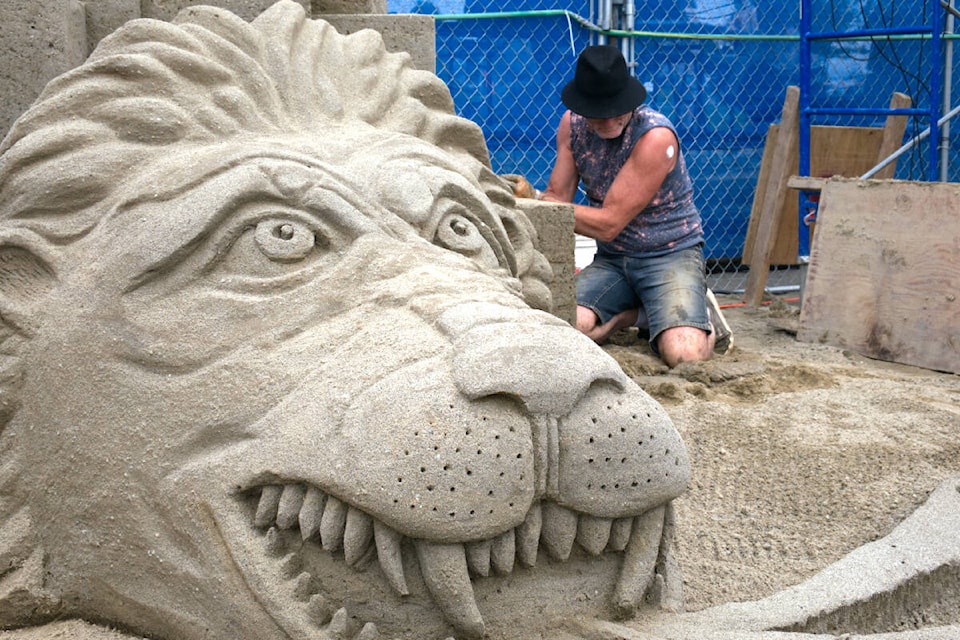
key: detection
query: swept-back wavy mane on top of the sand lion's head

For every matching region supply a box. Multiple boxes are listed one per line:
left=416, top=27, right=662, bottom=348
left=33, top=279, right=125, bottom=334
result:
left=0, top=0, right=501, bottom=242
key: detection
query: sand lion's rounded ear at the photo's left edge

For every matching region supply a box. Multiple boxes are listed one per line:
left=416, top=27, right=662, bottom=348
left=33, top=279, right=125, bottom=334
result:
left=0, top=230, right=57, bottom=336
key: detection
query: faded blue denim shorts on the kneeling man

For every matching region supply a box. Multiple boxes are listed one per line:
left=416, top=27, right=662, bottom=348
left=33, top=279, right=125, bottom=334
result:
left=577, top=245, right=710, bottom=345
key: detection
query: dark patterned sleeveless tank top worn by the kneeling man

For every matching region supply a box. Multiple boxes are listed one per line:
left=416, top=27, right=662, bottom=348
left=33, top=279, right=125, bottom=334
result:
left=570, top=105, right=703, bottom=257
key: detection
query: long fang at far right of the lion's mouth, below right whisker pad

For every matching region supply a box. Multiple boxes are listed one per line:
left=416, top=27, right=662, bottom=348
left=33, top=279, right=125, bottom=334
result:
left=613, top=506, right=664, bottom=617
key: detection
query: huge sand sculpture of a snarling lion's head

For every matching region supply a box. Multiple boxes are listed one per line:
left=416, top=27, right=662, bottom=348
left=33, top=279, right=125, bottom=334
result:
left=0, top=0, right=689, bottom=640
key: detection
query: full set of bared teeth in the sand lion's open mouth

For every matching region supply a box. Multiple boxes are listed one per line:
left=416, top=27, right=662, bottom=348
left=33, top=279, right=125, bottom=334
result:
left=248, top=484, right=664, bottom=638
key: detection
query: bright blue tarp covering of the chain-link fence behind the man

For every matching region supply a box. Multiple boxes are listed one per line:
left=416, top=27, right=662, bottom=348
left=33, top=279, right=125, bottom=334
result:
left=390, top=0, right=960, bottom=289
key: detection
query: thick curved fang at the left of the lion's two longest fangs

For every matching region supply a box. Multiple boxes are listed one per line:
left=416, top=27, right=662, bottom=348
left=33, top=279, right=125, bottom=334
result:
left=415, top=540, right=484, bottom=640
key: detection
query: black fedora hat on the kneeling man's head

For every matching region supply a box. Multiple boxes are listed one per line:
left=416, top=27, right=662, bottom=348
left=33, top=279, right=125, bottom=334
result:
left=560, top=45, right=647, bottom=118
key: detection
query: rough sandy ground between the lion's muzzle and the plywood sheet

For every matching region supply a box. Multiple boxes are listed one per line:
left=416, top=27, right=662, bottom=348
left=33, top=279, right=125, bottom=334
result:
left=605, top=296, right=960, bottom=624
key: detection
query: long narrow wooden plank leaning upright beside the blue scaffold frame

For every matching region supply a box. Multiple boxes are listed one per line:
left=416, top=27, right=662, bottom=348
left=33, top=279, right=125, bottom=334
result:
left=744, top=86, right=800, bottom=306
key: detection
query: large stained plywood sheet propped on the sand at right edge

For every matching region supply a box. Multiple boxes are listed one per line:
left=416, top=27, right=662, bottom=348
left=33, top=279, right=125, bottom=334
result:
left=797, top=178, right=960, bottom=373
